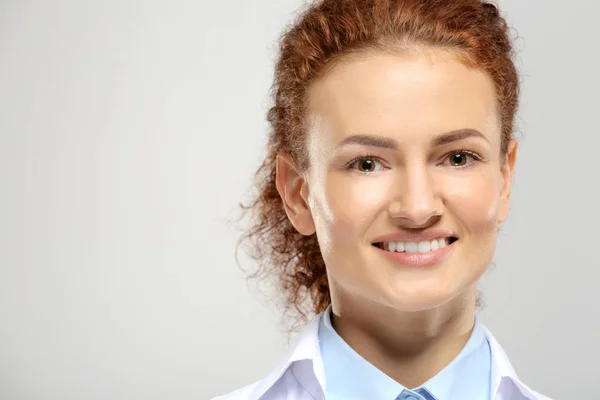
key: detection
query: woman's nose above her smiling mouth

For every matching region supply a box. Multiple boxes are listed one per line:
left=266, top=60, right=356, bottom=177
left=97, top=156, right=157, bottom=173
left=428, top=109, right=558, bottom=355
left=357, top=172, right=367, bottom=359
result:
left=388, top=164, right=444, bottom=229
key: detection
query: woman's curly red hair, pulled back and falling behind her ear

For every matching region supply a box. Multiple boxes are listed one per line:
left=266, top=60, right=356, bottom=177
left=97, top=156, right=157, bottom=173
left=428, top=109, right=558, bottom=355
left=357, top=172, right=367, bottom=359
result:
left=240, top=0, right=519, bottom=326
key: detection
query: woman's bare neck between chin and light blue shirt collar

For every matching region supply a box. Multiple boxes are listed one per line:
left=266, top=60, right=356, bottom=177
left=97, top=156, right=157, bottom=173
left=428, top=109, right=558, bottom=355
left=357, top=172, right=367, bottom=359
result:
left=331, top=287, right=476, bottom=388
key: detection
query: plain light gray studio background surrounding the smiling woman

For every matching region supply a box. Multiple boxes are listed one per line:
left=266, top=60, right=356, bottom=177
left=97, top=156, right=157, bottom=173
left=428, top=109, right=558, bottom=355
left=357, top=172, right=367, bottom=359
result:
left=0, top=0, right=600, bottom=400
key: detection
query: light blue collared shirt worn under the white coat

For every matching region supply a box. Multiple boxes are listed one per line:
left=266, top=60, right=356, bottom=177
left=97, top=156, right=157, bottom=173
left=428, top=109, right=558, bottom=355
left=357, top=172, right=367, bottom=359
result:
left=319, top=306, right=492, bottom=400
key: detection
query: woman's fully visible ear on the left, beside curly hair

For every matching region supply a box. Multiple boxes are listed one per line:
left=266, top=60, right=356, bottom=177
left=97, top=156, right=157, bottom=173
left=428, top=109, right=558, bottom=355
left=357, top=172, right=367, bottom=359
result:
left=276, top=153, right=315, bottom=236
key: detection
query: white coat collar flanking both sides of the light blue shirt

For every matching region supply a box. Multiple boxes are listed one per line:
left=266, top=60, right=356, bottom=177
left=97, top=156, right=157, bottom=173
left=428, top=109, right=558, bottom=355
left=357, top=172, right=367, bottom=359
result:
left=248, top=313, right=551, bottom=400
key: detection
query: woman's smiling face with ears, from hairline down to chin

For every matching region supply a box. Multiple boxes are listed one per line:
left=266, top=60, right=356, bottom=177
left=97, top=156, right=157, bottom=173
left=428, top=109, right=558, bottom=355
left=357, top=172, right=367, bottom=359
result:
left=278, top=51, right=516, bottom=311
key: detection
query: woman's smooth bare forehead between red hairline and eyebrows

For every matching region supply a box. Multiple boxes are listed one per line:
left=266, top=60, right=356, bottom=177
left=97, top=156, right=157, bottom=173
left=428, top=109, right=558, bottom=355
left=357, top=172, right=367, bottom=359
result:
left=307, top=50, right=500, bottom=146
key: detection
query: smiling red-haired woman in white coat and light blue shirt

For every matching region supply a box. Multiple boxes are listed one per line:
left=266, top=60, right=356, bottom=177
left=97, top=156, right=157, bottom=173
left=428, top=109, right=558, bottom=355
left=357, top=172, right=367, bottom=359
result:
left=217, top=0, right=547, bottom=400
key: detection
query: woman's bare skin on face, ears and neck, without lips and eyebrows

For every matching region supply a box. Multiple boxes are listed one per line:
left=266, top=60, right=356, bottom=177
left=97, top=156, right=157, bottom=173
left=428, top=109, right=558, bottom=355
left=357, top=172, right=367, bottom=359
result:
left=277, top=50, right=516, bottom=386
